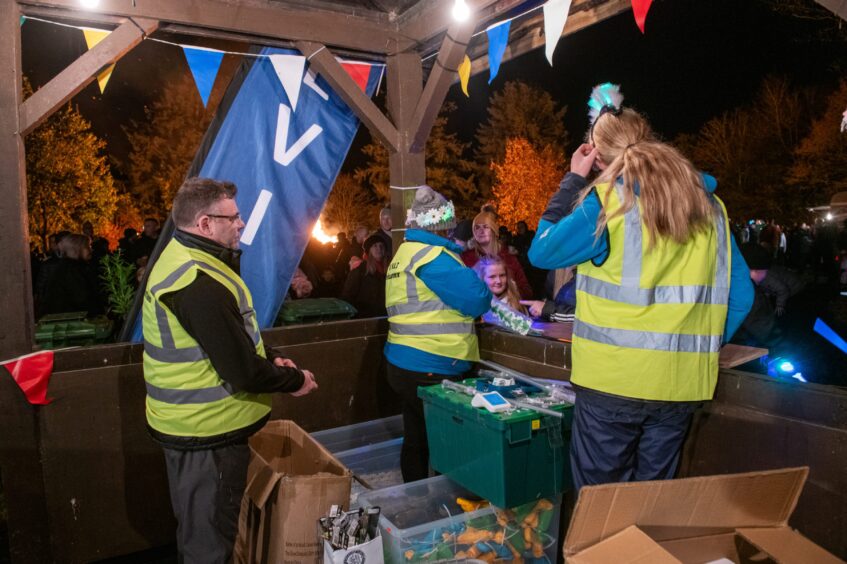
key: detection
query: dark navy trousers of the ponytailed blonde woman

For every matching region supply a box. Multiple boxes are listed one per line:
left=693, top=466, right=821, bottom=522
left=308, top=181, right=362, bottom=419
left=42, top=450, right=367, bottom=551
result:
left=571, top=388, right=699, bottom=492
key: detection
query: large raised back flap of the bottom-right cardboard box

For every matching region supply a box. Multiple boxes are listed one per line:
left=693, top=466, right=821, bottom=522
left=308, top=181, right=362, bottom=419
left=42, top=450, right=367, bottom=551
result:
left=565, top=467, right=809, bottom=555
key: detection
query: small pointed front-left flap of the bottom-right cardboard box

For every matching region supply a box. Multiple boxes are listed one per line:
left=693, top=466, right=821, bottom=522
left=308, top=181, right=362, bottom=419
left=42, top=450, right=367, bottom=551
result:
left=568, top=525, right=681, bottom=564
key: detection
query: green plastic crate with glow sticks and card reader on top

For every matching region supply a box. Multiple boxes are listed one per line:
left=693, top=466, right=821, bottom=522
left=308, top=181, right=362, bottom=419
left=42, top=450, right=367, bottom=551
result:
left=418, top=379, right=573, bottom=507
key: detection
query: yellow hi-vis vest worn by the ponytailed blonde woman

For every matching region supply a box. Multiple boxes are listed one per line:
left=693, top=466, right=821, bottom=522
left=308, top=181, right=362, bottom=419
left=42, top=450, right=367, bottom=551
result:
left=571, top=184, right=730, bottom=401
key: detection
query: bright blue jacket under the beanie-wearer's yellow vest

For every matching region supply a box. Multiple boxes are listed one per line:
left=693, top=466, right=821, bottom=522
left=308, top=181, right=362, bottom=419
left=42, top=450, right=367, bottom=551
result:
left=385, top=229, right=491, bottom=376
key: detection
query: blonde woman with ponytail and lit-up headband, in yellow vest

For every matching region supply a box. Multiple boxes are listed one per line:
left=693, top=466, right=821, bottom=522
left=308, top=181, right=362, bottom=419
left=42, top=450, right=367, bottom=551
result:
left=529, top=84, right=753, bottom=490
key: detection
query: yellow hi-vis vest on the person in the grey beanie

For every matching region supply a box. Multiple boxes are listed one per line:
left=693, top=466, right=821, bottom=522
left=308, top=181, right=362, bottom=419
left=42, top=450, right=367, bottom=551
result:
left=385, top=241, right=479, bottom=362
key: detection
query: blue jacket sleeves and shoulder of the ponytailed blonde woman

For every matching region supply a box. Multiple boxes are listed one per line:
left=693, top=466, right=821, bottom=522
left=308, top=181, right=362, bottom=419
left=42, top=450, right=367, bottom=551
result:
left=528, top=172, right=754, bottom=342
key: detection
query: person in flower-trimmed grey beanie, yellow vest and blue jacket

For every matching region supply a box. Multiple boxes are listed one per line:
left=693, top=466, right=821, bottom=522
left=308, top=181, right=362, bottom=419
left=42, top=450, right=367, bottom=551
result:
left=385, top=186, right=491, bottom=482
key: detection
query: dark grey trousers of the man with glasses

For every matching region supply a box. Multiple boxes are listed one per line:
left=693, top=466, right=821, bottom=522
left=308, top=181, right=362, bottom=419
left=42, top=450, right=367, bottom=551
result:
left=163, top=441, right=250, bottom=564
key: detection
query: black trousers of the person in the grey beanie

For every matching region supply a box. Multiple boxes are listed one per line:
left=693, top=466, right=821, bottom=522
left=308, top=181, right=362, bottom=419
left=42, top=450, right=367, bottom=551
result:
left=387, top=362, right=464, bottom=482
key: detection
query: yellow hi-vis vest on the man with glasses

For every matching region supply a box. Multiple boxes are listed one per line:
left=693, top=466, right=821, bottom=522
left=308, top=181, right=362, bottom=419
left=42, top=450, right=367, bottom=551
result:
left=142, top=239, right=271, bottom=437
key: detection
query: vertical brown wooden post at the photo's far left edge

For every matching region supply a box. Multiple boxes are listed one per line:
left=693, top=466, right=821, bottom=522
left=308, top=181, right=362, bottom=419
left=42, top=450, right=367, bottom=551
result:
left=0, top=0, right=33, bottom=360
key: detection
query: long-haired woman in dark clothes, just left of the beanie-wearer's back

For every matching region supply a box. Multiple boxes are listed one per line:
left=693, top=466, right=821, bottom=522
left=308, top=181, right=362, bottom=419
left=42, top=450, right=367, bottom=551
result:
left=341, top=234, right=386, bottom=317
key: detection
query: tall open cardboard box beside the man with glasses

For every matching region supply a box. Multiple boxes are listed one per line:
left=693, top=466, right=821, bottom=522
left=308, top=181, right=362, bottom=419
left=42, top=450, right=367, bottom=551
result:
left=234, top=421, right=353, bottom=564
